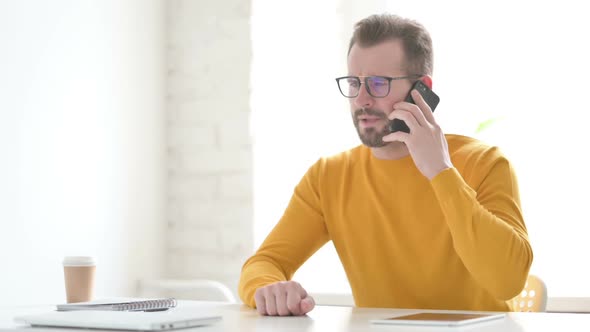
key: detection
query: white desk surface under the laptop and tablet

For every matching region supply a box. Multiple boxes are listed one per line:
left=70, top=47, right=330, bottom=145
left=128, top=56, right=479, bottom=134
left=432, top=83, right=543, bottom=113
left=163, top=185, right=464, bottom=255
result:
left=0, top=301, right=590, bottom=332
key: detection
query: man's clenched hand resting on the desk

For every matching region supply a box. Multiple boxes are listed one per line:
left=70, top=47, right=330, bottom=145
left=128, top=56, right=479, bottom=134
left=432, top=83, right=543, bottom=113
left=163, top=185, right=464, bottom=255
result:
left=254, top=281, right=315, bottom=316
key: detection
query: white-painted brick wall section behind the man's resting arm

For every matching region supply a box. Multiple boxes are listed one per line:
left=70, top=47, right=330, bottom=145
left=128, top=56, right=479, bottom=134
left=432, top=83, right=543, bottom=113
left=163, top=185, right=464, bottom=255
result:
left=166, top=0, right=253, bottom=293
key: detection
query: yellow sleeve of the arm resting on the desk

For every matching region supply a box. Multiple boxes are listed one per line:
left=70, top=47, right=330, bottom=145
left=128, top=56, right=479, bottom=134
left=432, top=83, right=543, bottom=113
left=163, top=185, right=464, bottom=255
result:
left=238, top=160, right=329, bottom=307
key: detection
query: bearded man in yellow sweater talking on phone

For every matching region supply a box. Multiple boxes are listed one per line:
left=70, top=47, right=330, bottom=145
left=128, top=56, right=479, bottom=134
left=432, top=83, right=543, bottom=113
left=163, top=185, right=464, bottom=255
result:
left=239, top=15, right=533, bottom=316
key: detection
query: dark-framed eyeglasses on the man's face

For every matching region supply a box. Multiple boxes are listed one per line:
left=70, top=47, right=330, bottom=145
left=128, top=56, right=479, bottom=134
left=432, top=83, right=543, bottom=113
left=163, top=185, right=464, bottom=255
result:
left=336, top=75, right=423, bottom=98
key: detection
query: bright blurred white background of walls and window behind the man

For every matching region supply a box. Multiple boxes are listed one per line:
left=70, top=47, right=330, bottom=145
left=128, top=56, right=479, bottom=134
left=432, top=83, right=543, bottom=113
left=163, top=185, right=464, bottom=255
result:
left=0, top=0, right=590, bottom=305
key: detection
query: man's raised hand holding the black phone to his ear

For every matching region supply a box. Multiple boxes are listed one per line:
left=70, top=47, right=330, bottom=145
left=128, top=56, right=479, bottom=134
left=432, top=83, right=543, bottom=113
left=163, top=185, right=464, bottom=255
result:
left=383, top=85, right=453, bottom=180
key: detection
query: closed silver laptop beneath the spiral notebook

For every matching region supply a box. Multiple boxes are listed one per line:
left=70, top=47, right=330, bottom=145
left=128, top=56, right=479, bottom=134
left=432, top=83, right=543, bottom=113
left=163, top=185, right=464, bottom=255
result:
left=14, top=308, right=221, bottom=331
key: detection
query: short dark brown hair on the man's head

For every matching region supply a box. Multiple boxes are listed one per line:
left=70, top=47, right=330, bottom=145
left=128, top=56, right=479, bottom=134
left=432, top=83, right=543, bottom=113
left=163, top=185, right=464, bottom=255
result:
left=348, top=14, right=433, bottom=75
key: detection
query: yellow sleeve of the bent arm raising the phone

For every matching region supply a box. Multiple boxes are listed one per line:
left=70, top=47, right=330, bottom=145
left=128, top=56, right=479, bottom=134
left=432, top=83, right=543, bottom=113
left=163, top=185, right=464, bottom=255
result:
left=431, top=156, right=533, bottom=300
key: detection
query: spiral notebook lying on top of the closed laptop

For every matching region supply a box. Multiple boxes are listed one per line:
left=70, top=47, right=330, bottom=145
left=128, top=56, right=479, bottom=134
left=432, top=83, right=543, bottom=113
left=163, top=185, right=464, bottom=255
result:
left=57, top=298, right=176, bottom=311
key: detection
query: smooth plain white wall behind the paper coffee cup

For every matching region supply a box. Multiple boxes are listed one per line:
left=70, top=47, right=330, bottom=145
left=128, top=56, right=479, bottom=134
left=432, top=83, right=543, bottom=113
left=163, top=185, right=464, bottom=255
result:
left=0, top=0, right=165, bottom=304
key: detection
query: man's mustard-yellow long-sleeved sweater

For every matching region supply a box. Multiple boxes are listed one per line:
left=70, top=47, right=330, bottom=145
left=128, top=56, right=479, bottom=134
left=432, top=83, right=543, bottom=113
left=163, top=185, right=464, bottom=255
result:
left=239, top=135, right=533, bottom=311
